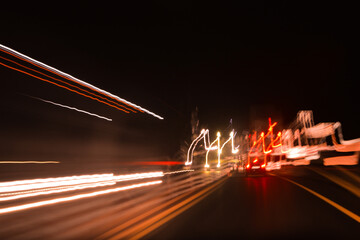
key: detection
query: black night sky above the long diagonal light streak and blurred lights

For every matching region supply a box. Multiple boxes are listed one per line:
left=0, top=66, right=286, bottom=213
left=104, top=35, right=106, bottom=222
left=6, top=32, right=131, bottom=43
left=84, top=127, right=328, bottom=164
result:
left=0, top=1, right=360, bottom=161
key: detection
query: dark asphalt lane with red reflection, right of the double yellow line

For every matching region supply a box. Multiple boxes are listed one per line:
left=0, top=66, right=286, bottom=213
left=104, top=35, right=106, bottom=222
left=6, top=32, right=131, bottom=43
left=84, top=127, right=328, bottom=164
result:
left=145, top=166, right=360, bottom=239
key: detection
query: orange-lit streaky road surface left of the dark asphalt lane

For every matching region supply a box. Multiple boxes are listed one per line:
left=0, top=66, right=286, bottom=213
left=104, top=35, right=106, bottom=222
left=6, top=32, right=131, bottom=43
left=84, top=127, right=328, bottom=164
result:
left=0, top=164, right=228, bottom=239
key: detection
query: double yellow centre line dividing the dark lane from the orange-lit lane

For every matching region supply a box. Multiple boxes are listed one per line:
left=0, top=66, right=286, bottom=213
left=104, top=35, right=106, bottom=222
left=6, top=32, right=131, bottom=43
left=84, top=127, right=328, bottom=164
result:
left=109, top=177, right=227, bottom=240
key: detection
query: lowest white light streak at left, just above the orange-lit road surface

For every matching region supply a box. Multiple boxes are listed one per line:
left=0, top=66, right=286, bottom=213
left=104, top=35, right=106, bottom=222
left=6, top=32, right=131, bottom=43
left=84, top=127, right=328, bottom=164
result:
left=0, top=180, right=162, bottom=214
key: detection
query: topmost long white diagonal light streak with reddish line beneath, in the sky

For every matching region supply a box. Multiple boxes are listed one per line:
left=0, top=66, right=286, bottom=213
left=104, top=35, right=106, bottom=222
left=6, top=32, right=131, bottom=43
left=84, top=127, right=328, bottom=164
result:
left=0, top=44, right=164, bottom=120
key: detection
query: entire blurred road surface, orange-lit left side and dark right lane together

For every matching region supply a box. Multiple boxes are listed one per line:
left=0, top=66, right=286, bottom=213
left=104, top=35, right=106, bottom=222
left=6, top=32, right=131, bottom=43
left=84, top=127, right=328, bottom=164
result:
left=0, top=164, right=360, bottom=239
